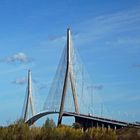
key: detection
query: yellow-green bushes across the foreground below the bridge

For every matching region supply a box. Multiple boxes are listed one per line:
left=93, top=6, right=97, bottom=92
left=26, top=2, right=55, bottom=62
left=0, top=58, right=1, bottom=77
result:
left=0, top=119, right=140, bottom=140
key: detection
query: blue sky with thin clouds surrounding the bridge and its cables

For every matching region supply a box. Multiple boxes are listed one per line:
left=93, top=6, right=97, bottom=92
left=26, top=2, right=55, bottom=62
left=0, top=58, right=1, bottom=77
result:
left=0, top=0, right=140, bottom=125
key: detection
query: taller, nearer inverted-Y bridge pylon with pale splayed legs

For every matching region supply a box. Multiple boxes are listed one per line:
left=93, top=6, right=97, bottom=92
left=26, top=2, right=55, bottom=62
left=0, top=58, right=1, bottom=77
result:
left=58, top=29, right=79, bottom=125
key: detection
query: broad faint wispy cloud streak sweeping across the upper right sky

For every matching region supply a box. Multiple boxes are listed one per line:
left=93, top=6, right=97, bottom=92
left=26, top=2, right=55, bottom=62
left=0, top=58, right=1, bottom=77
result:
left=74, top=9, right=140, bottom=45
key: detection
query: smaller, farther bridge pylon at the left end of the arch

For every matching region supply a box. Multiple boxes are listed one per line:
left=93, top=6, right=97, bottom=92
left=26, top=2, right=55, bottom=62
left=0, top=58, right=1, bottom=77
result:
left=23, top=70, right=35, bottom=122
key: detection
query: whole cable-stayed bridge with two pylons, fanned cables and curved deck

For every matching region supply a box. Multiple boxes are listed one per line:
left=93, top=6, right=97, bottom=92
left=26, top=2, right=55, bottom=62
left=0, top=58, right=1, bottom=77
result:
left=23, top=29, right=139, bottom=129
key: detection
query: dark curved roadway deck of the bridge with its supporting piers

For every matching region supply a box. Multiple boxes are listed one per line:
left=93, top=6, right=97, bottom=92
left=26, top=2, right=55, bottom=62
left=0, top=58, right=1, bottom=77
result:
left=26, top=111, right=136, bottom=129
